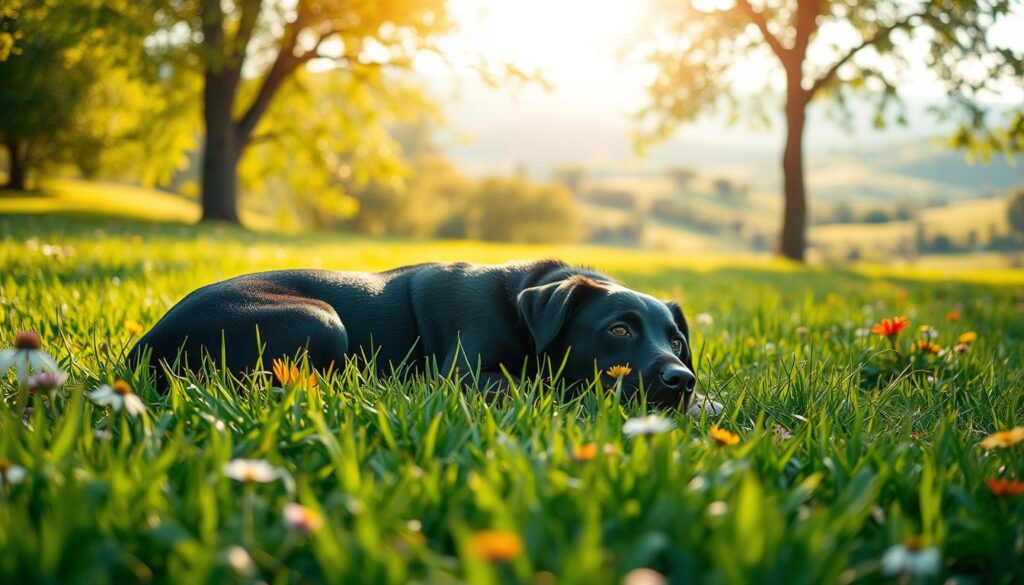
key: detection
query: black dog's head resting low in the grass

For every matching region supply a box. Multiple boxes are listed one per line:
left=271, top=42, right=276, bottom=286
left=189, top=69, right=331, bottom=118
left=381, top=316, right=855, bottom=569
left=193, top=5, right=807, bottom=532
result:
left=517, top=276, right=696, bottom=409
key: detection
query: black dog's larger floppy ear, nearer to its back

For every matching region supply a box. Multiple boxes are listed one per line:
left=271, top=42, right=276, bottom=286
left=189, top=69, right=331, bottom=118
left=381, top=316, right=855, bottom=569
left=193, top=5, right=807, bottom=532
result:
left=516, top=276, right=603, bottom=353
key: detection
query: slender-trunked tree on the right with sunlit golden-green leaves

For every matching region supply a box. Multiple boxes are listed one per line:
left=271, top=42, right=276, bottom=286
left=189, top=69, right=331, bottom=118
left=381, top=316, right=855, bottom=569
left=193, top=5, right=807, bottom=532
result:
left=639, top=0, right=1024, bottom=260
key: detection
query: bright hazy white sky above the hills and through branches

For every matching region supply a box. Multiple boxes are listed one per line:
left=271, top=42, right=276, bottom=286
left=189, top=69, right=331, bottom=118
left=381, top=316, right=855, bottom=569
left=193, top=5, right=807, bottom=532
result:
left=407, top=0, right=1024, bottom=175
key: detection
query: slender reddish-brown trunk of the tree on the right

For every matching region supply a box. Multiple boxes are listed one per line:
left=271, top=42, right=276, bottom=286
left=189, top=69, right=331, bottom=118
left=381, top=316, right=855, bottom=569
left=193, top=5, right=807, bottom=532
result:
left=779, top=93, right=807, bottom=262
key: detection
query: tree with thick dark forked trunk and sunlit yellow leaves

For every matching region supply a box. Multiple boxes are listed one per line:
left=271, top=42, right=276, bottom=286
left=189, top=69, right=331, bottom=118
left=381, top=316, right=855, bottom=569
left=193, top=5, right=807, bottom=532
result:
left=152, top=0, right=450, bottom=223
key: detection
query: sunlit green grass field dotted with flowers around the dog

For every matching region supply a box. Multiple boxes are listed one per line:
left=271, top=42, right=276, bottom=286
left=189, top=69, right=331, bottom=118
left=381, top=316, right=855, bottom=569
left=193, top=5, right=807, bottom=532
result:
left=0, top=182, right=1024, bottom=585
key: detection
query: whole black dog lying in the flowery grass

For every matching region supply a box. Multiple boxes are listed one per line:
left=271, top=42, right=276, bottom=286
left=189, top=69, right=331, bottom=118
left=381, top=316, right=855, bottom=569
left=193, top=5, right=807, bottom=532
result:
left=130, top=260, right=696, bottom=408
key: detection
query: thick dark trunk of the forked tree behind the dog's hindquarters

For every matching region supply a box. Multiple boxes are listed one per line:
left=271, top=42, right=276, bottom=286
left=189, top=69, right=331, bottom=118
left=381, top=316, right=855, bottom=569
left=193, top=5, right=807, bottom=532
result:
left=202, top=71, right=241, bottom=223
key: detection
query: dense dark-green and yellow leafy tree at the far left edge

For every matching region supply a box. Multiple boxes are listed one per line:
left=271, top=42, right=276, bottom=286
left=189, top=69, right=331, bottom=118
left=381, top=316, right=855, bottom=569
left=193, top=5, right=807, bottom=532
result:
left=0, top=0, right=190, bottom=191
